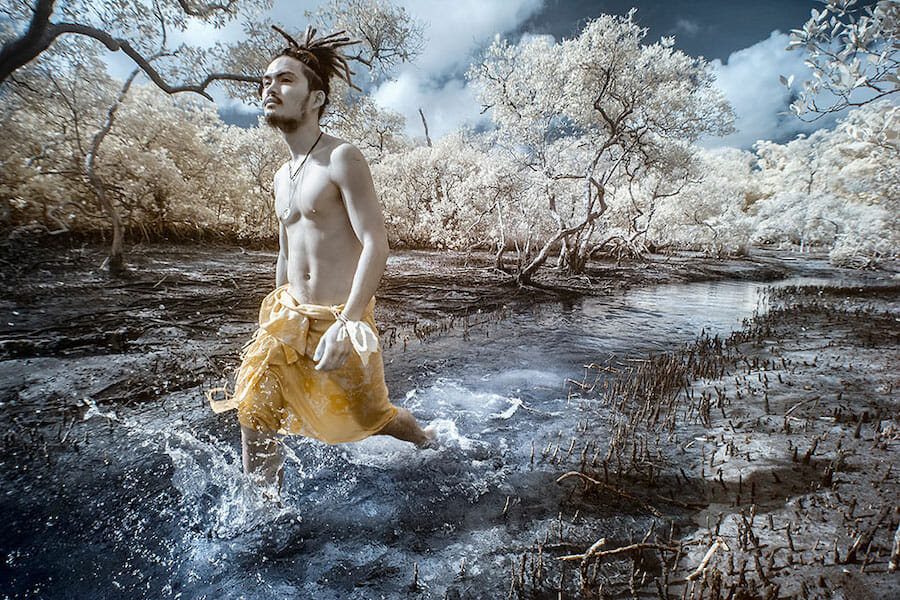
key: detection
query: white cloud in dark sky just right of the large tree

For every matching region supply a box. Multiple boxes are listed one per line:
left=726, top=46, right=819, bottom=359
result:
left=703, top=31, right=836, bottom=149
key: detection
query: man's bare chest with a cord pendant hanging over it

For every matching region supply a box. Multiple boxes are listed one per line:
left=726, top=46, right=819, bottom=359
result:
left=275, top=164, right=343, bottom=225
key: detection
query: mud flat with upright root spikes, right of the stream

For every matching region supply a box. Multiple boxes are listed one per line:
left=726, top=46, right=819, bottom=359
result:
left=536, top=282, right=900, bottom=600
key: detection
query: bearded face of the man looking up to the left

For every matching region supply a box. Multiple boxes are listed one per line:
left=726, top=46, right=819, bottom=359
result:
left=262, top=56, right=324, bottom=133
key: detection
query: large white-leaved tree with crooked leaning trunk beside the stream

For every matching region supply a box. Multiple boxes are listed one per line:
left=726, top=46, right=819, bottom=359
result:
left=468, top=11, right=731, bottom=277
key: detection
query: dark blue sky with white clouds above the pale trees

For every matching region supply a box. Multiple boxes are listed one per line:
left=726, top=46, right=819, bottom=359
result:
left=107, top=0, right=880, bottom=148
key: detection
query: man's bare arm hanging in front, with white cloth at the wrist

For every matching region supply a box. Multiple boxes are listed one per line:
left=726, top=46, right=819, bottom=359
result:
left=314, top=144, right=389, bottom=371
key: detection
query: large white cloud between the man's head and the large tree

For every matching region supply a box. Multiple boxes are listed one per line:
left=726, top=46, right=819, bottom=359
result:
left=372, top=0, right=543, bottom=139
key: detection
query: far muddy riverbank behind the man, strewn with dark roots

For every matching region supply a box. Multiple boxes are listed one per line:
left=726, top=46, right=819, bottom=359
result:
left=0, top=244, right=791, bottom=440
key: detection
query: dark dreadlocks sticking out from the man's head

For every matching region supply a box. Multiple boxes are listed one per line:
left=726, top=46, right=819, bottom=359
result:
left=259, top=25, right=362, bottom=118
